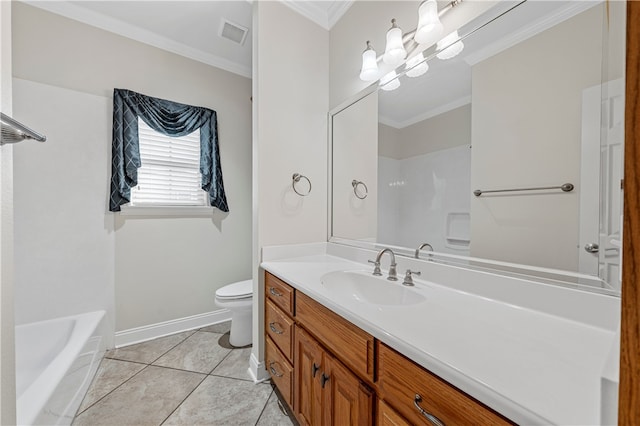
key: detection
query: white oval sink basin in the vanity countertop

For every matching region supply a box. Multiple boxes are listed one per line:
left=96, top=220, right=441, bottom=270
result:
left=320, top=271, right=425, bottom=306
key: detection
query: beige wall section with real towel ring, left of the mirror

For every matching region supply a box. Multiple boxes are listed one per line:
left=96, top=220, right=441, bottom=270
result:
left=253, top=1, right=329, bottom=376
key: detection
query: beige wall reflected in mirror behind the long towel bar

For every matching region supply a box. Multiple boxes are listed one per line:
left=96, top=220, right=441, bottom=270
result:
left=471, top=5, right=604, bottom=270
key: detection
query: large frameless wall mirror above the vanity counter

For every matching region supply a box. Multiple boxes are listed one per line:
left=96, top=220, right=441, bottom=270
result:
left=331, top=0, right=626, bottom=294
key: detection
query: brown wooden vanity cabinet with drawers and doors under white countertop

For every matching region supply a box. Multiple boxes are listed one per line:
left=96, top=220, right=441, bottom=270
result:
left=265, top=273, right=512, bottom=426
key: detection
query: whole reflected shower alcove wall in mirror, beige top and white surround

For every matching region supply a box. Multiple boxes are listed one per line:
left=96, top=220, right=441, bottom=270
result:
left=378, top=104, right=471, bottom=255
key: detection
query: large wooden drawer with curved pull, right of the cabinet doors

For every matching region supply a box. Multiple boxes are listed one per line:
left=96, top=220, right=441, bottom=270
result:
left=378, top=344, right=511, bottom=425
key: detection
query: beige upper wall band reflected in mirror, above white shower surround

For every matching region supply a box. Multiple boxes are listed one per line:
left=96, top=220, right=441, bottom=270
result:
left=378, top=104, right=471, bottom=160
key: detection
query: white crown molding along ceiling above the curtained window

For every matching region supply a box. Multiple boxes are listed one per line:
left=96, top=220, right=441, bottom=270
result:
left=24, top=0, right=252, bottom=78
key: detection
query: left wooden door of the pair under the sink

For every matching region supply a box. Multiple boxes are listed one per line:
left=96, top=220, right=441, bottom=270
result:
left=294, top=326, right=324, bottom=425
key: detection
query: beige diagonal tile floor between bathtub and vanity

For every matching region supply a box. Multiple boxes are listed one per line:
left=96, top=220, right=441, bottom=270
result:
left=73, top=322, right=295, bottom=426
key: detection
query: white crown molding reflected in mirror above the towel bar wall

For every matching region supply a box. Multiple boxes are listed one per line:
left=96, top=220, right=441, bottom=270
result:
left=464, top=0, right=602, bottom=66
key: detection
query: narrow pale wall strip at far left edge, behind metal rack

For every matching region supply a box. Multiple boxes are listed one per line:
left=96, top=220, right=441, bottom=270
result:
left=0, top=1, right=16, bottom=425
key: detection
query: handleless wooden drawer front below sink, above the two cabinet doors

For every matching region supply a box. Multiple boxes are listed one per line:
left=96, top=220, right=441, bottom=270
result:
left=296, top=292, right=373, bottom=383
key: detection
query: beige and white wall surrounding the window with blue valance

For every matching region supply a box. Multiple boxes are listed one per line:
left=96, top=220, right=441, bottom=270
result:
left=12, top=2, right=251, bottom=340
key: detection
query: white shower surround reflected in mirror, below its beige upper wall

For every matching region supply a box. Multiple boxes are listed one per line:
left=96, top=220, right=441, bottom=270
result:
left=378, top=145, right=471, bottom=256
